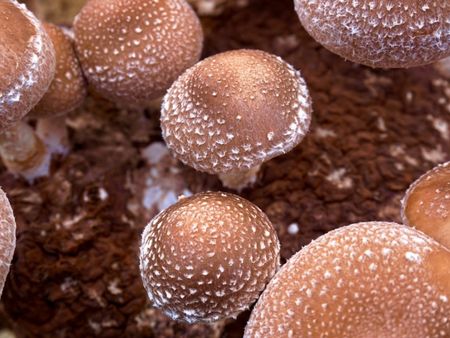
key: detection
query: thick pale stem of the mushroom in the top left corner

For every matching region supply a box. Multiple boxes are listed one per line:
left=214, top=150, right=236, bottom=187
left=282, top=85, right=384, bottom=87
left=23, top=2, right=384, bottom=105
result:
left=0, top=121, right=50, bottom=181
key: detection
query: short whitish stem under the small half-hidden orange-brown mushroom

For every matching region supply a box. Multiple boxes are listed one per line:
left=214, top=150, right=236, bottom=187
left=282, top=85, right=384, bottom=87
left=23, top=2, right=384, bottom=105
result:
left=36, top=117, right=70, bottom=155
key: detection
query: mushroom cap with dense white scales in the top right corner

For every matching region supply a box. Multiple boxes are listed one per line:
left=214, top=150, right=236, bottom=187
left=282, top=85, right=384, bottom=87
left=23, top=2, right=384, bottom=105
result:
left=294, top=0, right=450, bottom=68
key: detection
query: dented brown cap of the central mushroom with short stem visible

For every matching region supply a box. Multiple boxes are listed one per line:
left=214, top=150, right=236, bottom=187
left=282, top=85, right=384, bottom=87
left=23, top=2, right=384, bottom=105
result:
left=161, top=50, right=312, bottom=174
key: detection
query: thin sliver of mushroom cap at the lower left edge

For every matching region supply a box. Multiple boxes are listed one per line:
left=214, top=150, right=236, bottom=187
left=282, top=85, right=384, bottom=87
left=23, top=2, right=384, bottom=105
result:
left=0, top=189, right=16, bottom=296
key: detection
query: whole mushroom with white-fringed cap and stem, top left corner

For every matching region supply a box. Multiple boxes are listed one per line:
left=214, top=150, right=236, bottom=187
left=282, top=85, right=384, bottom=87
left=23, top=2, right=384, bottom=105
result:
left=0, top=0, right=55, bottom=179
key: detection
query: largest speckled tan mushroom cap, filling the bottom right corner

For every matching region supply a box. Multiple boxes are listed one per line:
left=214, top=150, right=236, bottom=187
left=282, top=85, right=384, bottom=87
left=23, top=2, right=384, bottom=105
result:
left=244, top=222, right=450, bottom=338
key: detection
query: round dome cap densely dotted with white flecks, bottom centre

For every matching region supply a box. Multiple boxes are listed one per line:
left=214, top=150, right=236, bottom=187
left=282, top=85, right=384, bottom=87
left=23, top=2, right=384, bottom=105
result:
left=140, top=192, right=280, bottom=323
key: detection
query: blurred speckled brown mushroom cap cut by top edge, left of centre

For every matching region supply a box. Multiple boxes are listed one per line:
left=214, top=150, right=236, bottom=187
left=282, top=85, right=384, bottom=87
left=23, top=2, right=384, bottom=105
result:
left=74, top=0, right=203, bottom=106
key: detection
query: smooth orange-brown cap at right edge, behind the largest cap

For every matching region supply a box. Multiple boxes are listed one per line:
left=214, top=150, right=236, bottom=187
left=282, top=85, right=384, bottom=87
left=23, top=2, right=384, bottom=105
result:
left=402, top=162, right=450, bottom=248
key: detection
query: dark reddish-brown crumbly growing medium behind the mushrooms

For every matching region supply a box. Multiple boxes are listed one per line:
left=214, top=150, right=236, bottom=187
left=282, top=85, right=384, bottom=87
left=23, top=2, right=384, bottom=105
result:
left=0, top=0, right=450, bottom=338
